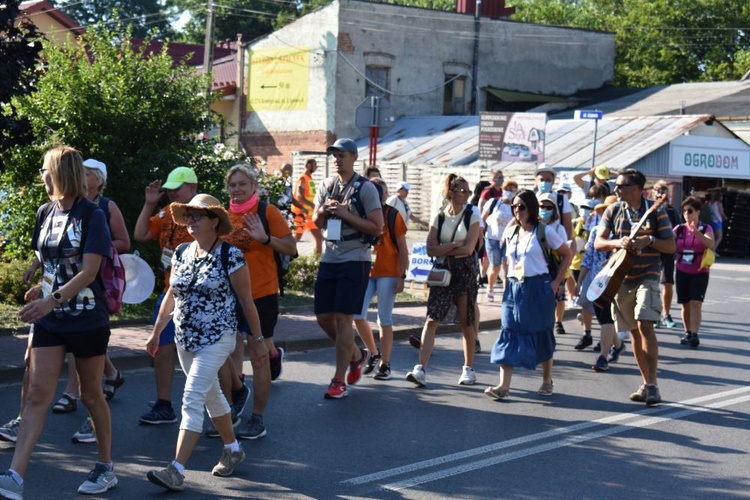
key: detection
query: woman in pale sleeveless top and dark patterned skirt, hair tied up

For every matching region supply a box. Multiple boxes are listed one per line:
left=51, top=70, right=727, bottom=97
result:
left=406, top=174, right=481, bottom=387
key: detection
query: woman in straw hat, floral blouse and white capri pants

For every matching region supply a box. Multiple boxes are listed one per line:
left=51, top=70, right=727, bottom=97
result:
left=146, top=194, right=262, bottom=491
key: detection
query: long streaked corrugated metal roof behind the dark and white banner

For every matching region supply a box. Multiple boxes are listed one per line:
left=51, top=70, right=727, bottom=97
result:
left=358, top=115, right=724, bottom=169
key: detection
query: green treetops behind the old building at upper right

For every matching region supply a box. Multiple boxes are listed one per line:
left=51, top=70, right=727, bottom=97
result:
left=513, top=0, right=750, bottom=86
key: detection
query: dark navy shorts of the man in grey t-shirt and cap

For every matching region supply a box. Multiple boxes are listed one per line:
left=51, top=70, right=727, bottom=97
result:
left=315, top=261, right=371, bottom=314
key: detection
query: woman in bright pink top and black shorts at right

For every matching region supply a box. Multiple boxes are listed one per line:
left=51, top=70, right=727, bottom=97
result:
left=674, top=197, right=714, bottom=349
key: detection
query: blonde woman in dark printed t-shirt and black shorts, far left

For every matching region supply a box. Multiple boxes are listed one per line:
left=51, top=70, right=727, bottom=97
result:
left=0, top=146, right=117, bottom=498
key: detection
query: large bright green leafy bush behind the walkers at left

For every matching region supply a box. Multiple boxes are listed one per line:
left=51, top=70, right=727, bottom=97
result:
left=0, top=25, right=223, bottom=257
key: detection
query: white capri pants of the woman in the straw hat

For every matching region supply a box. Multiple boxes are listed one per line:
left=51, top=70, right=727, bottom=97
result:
left=177, top=333, right=236, bottom=433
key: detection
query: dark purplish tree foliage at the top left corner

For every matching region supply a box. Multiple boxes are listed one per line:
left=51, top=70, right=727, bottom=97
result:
left=0, top=0, right=42, bottom=168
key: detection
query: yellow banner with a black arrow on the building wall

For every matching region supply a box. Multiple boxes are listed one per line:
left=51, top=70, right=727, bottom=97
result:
left=247, top=47, right=310, bottom=111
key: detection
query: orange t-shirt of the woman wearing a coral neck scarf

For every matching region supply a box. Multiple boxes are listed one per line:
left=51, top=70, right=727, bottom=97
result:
left=222, top=204, right=292, bottom=300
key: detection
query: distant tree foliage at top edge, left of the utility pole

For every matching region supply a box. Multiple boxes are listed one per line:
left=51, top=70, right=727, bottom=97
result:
left=58, top=0, right=173, bottom=39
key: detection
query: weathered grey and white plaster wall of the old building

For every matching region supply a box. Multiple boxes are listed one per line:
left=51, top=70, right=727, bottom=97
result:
left=243, top=0, right=615, bottom=161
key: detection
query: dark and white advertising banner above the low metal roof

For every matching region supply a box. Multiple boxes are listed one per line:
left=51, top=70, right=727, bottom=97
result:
left=479, top=112, right=547, bottom=163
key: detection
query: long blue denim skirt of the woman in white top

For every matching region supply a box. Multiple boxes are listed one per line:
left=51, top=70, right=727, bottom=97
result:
left=490, top=274, right=556, bottom=370
